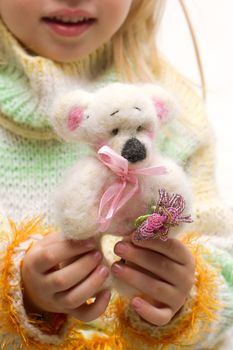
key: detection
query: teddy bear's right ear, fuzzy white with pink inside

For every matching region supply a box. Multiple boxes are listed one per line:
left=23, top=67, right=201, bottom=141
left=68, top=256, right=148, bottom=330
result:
left=145, top=84, right=179, bottom=124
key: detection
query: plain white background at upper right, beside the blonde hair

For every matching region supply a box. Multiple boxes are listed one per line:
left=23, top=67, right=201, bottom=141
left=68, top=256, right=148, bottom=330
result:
left=159, top=0, right=233, bottom=207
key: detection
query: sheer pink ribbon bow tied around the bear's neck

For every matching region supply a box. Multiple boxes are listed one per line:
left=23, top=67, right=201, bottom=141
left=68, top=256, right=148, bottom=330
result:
left=98, top=146, right=167, bottom=232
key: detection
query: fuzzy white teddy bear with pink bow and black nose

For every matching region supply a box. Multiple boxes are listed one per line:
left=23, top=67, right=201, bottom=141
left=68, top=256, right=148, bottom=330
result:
left=52, top=83, right=192, bottom=296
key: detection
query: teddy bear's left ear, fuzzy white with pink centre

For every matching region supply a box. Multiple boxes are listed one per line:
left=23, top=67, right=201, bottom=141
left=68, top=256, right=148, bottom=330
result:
left=51, top=90, right=92, bottom=142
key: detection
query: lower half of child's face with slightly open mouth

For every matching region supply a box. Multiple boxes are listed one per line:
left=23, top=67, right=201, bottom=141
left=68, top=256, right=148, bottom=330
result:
left=0, top=0, right=134, bottom=62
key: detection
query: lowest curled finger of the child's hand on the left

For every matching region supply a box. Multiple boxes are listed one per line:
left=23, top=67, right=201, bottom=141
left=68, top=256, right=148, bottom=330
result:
left=70, top=290, right=111, bottom=322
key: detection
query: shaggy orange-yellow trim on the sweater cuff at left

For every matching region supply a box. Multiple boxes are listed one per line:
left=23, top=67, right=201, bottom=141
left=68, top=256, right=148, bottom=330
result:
left=0, top=219, right=123, bottom=350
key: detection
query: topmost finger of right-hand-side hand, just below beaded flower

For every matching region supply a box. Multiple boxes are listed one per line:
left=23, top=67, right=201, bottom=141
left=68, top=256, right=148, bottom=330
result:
left=133, top=235, right=192, bottom=265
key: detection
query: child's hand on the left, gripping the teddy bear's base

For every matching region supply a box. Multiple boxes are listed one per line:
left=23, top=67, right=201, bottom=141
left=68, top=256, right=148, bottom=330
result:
left=22, top=234, right=110, bottom=322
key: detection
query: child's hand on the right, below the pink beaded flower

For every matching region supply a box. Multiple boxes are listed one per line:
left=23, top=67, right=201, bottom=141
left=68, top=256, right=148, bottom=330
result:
left=112, top=234, right=195, bottom=326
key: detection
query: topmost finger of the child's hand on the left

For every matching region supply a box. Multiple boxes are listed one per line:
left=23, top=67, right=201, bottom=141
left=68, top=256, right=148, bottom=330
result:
left=28, top=241, right=95, bottom=273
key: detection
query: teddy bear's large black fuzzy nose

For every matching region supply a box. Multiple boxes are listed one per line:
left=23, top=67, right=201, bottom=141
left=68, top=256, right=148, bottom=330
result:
left=121, top=137, right=146, bottom=163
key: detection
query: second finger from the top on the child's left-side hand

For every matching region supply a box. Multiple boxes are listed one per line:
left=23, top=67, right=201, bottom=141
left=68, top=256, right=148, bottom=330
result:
left=46, top=250, right=102, bottom=294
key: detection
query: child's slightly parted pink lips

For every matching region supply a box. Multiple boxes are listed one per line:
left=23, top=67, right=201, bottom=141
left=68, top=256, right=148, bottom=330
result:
left=42, top=17, right=96, bottom=37
